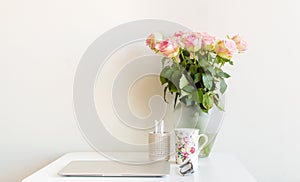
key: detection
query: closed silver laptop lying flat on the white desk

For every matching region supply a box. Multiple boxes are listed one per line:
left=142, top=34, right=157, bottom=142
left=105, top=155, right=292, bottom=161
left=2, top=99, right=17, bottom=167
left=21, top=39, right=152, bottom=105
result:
left=58, top=161, right=170, bottom=177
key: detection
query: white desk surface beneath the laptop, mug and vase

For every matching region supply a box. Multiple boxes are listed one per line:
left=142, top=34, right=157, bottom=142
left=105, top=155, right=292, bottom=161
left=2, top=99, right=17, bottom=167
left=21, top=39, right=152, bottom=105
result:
left=22, top=152, right=257, bottom=182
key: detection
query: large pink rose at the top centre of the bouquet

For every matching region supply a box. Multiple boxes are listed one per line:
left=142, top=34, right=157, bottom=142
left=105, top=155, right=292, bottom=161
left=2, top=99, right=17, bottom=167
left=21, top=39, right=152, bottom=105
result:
left=181, top=32, right=201, bottom=52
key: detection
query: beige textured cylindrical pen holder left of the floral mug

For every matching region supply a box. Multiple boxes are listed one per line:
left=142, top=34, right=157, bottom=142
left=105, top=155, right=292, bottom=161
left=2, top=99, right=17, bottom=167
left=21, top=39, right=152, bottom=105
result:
left=148, top=132, right=170, bottom=161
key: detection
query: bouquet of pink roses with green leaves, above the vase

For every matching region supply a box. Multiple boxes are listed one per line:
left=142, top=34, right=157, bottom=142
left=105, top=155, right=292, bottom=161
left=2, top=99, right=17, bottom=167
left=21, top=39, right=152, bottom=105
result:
left=146, top=31, right=247, bottom=112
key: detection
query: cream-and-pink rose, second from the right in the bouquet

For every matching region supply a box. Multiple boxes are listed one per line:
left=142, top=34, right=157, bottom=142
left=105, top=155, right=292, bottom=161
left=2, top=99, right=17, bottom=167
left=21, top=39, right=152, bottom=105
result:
left=216, top=39, right=238, bottom=59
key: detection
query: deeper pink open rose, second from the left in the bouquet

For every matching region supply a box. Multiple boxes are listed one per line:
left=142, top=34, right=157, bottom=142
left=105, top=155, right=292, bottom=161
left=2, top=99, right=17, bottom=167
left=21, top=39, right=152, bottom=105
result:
left=155, top=39, right=179, bottom=58
